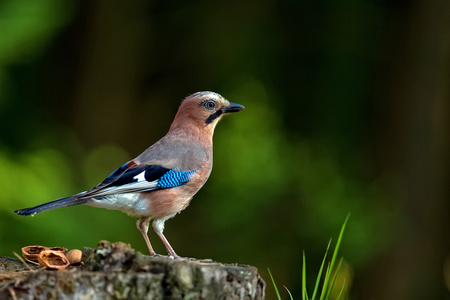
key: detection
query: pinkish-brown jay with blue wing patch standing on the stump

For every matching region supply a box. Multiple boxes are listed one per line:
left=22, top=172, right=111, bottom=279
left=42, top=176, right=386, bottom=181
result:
left=14, top=91, right=244, bottom=258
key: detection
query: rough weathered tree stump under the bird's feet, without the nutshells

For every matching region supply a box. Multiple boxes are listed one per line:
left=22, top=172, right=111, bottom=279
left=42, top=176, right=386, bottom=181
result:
left=0, top=241, right=265, bottom=300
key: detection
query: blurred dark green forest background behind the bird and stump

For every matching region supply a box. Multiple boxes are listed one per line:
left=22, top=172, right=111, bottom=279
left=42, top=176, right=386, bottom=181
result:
left=0, top=0, right=450, bottom=299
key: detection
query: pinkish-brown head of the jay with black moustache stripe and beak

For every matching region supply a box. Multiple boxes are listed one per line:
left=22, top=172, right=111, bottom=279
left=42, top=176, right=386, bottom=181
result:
left=171, top=92, right=244, bottom=133
